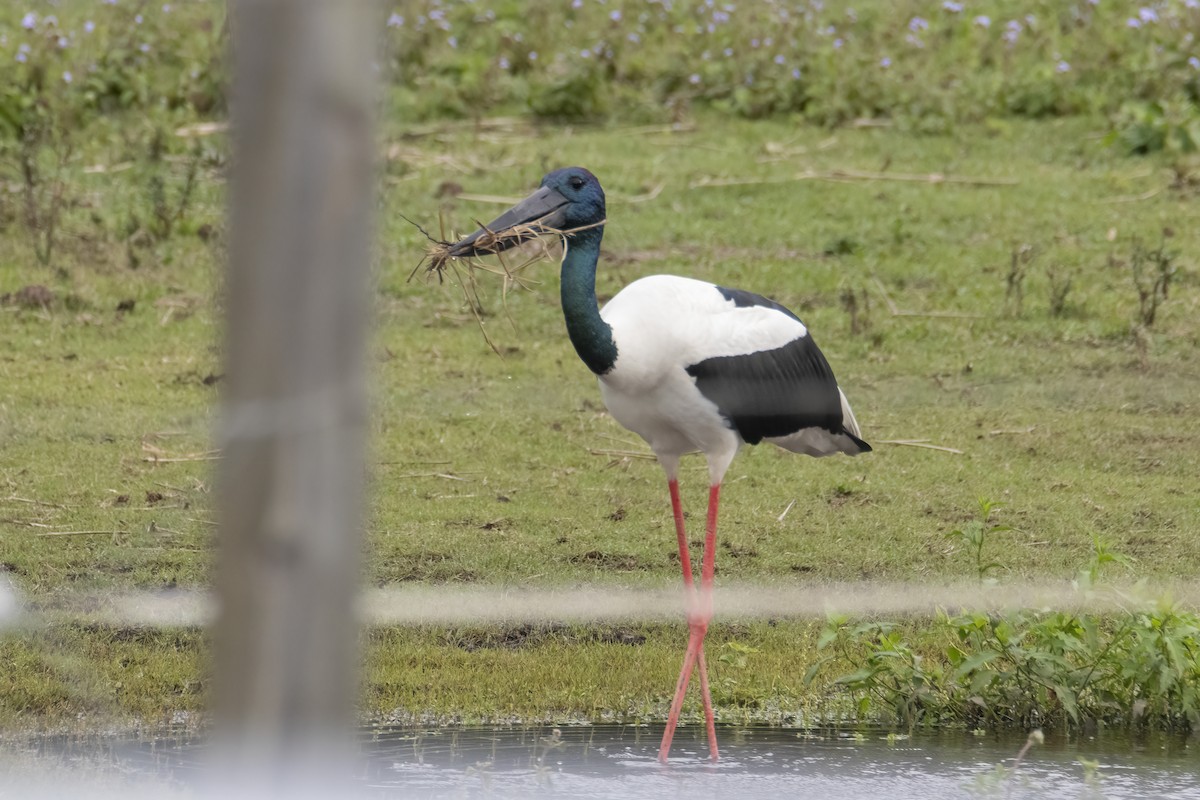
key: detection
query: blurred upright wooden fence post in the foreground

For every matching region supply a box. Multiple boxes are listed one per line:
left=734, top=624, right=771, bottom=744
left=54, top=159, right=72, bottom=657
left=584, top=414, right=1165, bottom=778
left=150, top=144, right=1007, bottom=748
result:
left=215, top=0, right=378, bottom=796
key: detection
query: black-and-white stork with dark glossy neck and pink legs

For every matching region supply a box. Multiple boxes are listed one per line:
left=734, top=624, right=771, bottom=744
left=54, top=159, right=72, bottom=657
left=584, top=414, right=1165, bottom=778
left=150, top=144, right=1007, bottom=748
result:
left=449, top=167, right=871, bottom=762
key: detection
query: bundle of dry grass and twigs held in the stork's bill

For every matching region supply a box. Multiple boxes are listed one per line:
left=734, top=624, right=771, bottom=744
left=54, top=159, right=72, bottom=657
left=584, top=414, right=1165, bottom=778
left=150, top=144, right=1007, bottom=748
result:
left=404, top=217, right=606, bottom=355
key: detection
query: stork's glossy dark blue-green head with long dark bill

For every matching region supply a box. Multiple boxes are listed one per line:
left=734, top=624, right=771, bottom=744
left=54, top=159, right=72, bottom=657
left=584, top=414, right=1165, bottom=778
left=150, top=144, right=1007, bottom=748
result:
left=449, top=167, right=605, bottom=258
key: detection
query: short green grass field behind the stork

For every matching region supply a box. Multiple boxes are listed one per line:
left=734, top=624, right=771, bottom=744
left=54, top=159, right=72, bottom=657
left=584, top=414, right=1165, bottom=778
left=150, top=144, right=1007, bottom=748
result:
left=0, top=114, right=1200, bottom=728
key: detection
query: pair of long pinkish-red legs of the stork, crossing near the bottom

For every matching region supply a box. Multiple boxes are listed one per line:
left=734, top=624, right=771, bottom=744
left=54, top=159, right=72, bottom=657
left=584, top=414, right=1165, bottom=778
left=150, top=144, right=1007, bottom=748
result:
left=659, top=479, right=720, bottom=763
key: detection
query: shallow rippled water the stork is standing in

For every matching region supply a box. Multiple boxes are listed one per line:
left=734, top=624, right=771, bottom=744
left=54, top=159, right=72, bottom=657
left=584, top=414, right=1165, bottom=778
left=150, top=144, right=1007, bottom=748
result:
left=0, top=726, right=1200, bottom=800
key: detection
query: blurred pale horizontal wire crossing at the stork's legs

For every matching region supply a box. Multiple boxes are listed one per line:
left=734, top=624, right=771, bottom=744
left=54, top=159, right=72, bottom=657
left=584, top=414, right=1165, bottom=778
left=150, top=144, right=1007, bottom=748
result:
left=0, top=582, right=1200, bottom=627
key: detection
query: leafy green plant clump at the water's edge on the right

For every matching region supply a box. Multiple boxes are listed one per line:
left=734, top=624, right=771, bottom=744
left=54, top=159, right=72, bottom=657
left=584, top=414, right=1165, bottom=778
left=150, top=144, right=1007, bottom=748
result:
left=804, top=499, right=1200, bottom=730
